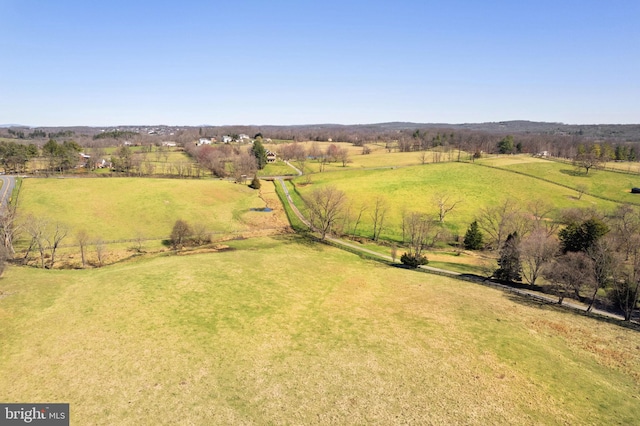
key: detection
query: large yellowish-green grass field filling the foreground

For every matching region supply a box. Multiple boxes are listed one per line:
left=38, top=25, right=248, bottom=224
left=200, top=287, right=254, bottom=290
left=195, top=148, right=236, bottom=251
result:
left=0, top=237, right=640, bottom=425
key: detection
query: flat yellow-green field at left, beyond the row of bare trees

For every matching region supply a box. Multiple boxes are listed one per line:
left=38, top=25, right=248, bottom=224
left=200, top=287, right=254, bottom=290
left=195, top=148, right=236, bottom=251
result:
left=18, top=178, right=265, bottom=241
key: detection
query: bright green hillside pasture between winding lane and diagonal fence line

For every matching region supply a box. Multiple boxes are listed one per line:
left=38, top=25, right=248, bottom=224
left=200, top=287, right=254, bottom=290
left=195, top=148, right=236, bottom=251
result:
left=294, top=162, right=615, bottom=240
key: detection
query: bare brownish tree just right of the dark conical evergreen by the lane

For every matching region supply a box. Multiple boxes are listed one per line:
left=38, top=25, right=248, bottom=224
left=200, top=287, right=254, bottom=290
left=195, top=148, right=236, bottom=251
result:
left=520, top=228, right=559, bottom=285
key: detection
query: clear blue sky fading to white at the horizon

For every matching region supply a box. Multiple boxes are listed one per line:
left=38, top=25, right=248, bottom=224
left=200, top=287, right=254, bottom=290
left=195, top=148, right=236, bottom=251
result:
left=0, top=0, right=640, bottom=126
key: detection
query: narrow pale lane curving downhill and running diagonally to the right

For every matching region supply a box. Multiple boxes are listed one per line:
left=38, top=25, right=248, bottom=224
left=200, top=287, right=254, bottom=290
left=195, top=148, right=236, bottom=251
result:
left=276, top=177, right=624, bottom=321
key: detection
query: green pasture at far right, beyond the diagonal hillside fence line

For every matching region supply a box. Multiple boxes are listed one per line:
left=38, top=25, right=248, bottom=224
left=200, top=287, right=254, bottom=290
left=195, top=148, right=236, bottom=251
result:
left=478, top=155, right=640, bottom=204
